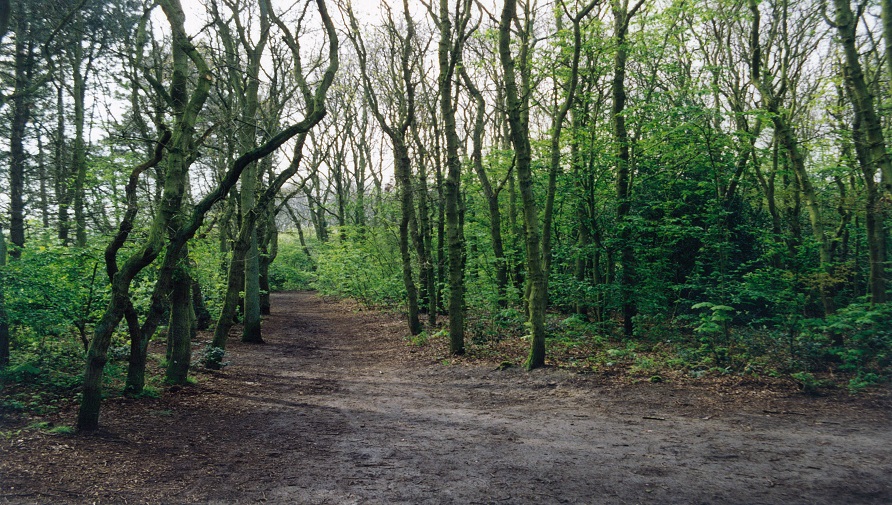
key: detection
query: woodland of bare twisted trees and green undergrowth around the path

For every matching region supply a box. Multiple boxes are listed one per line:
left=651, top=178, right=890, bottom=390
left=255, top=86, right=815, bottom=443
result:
left=0, top=0, right=892, bottom=430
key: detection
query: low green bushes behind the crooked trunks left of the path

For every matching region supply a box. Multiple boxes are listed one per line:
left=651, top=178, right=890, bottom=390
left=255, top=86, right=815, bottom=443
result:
left=0, top=228, right=223, bottom=418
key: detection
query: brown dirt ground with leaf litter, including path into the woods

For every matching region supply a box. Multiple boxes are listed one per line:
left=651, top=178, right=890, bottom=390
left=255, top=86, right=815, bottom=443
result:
left=0, top=292, right=892, bottom=504
